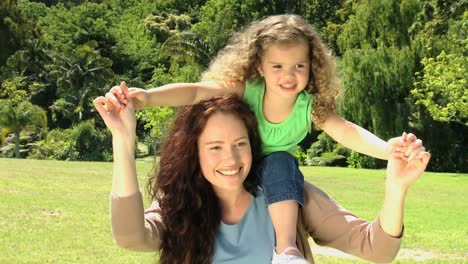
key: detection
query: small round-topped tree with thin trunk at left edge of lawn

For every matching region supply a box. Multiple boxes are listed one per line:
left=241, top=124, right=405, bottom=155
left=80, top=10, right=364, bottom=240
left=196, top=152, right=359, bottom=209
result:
left=0, top=100, right=47, bottom=158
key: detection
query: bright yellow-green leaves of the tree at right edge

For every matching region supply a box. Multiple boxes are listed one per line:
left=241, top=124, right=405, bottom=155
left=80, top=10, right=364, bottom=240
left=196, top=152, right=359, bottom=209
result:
left=411, top=9, right=468, bottom=125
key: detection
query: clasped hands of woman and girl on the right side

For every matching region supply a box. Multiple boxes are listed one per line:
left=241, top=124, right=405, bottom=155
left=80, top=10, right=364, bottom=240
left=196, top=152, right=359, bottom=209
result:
left=387, top=133, right=431, bottom=189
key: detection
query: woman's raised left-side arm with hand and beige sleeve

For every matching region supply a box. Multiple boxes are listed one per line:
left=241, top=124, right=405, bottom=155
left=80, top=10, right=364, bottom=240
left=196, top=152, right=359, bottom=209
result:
left=93, top=96, right=162, bottom=251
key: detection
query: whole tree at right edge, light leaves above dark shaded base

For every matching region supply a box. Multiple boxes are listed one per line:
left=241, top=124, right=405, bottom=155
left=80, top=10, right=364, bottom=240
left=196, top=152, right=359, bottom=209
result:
left=409, top=0, right=468, bottom=172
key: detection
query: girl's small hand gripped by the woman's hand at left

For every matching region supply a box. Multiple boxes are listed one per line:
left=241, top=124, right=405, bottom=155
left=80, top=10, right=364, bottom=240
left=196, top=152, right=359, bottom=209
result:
left=106, top=81, right=148, bottom=110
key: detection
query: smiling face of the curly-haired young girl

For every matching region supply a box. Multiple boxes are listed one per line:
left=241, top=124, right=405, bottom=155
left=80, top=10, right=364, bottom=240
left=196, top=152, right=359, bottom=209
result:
left=258, top=41, right=310, bottom=99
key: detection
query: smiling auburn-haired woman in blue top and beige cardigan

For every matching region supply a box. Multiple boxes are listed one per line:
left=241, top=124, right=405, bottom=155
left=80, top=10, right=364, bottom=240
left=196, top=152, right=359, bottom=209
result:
left=94, top=95, right=430, bottom=263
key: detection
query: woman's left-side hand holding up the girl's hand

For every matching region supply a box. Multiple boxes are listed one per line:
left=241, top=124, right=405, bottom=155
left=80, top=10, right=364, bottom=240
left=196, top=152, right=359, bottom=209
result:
left=93, top=93, right=136, bottom=137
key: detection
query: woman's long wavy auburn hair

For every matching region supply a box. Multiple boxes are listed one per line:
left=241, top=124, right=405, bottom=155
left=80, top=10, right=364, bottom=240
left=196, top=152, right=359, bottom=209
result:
left=147, top=95, right=261, bottom=264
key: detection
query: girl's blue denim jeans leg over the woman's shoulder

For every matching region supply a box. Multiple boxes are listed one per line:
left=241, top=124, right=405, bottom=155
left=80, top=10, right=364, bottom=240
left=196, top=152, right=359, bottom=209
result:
left=260, top=152, right=304, bottom=206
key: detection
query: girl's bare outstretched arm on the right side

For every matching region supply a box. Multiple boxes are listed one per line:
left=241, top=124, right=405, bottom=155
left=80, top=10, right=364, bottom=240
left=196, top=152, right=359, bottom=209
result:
left=318, top=113, right=414, bottom=160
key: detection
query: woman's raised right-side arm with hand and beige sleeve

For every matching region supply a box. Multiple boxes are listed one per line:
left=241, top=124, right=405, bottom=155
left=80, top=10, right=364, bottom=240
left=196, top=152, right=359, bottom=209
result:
left=303, top=136, right=430, bottom=262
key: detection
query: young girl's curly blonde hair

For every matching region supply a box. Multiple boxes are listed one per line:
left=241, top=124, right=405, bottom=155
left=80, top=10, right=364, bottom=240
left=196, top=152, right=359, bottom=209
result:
left=202, top=15, right=340, bottom=124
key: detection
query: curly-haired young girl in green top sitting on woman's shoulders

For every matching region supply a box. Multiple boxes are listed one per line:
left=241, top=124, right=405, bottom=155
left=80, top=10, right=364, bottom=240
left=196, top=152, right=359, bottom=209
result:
left=106, top=15, right=412, bottom=263
